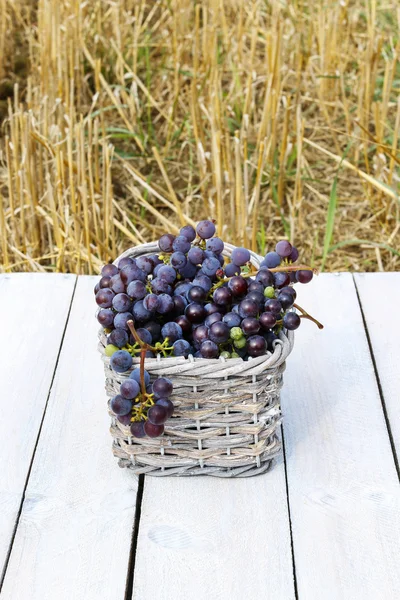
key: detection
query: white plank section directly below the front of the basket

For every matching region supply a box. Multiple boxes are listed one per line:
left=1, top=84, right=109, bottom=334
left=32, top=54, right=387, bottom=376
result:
left=133, top=458, right=294, bottom=600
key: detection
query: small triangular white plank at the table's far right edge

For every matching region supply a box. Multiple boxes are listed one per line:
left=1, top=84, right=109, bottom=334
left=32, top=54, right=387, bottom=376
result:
left=354, top=273, right=400, bottom=458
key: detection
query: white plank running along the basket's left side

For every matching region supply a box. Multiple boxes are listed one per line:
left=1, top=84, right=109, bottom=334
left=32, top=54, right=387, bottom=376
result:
left=0, top=277, right=137, bottom=600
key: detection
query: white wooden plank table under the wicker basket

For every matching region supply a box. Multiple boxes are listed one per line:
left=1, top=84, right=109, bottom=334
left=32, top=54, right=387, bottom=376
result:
left=0, top=273, right=400, bottom=600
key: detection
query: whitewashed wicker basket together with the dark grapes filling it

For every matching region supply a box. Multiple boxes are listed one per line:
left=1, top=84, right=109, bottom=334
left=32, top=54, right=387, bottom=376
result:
left=95, top=221, right=322, bottom=477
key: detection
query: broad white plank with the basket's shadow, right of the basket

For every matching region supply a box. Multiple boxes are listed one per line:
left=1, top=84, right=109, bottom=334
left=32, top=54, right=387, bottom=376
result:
left=282, top=273, right=400, bottom=600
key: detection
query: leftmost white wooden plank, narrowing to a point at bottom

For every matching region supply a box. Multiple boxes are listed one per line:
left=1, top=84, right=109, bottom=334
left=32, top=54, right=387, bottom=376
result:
left=0, top=273, right=76, bottom=573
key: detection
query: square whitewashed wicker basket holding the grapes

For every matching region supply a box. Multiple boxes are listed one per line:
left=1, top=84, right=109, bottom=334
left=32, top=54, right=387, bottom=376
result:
left=99, top=243, right=294, bottom=477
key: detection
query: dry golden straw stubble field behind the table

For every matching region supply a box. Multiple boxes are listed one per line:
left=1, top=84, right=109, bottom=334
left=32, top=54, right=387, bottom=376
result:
left=0, top=0, right=400, bottom=273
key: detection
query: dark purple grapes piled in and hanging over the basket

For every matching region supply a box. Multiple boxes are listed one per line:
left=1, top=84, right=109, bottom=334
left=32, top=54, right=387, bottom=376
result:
left=95, top=220, right=320, bottom=437
